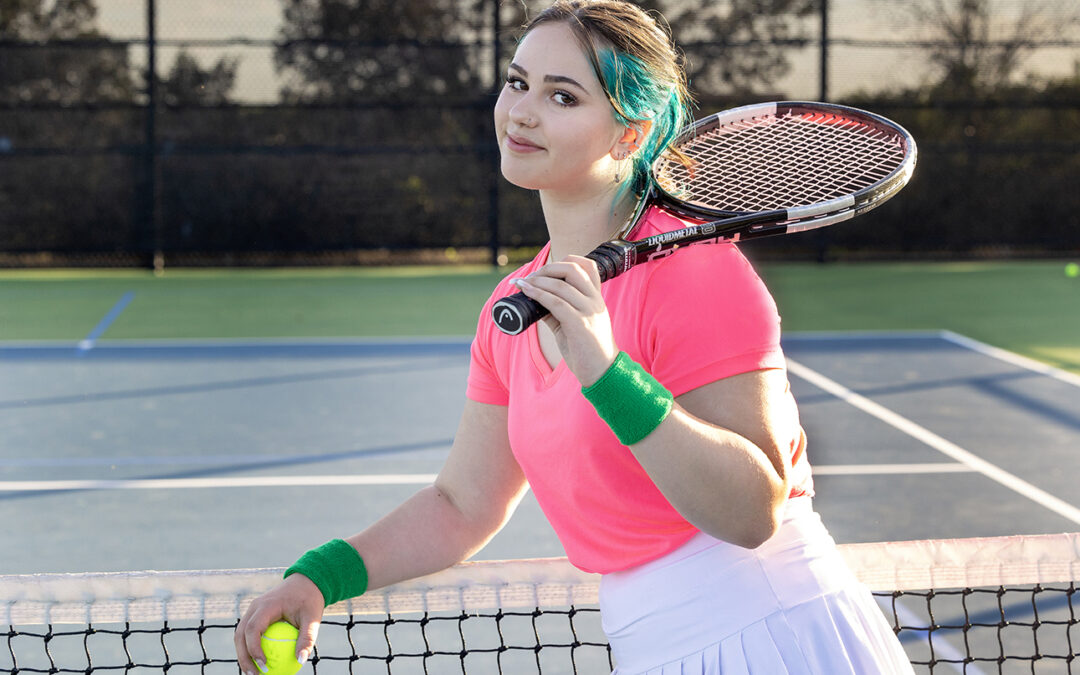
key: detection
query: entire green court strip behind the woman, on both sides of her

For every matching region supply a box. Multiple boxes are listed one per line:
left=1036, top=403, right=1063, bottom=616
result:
left=0, top=261, right=1080, bottom=373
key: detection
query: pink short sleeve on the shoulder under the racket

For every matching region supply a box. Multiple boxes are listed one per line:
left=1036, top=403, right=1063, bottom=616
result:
left=640, top=244, right=785, bottom=396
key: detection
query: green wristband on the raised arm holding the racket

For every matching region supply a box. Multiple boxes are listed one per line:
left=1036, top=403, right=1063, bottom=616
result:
left=581, top=352, right=675, bottom=445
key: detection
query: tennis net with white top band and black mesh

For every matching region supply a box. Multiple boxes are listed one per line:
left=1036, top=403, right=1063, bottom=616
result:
left=0, top=534, right=1080, bottom=675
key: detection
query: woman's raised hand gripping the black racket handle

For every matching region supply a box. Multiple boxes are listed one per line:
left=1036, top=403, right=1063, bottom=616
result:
left=517, top=255, right=619, bottom=387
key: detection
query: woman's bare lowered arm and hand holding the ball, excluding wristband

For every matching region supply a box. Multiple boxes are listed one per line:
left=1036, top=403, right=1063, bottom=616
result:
left=234, top=401, right=526, bottom=675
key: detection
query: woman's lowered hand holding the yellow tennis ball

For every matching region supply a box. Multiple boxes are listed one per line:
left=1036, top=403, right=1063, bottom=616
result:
left=232, top=575, right=324, bottom=675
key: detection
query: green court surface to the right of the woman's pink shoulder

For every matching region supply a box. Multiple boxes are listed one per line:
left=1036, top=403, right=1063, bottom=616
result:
left=760, top=260, right=1080, bottom=373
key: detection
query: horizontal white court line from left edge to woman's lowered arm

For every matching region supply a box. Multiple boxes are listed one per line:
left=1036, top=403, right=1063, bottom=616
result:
left=0, top=473, right=437, bottom=492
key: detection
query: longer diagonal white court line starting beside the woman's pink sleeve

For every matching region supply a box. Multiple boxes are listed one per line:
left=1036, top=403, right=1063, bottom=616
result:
left=787, top=359, right=1080, bottom=524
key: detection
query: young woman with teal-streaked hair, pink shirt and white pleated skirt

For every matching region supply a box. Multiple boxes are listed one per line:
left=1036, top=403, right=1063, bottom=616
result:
left=237, top=0, right=912, bottom=675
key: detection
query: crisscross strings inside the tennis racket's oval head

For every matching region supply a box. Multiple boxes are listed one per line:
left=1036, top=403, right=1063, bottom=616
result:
left=657, top=113, right=905, bottom=213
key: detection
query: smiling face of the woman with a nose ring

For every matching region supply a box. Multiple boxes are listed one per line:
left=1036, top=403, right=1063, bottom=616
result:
left=495, top=23, right=625, bottom=193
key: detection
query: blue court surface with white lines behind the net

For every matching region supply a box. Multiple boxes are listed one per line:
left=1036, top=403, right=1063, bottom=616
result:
left=0, top=333, right=1080, bottom=573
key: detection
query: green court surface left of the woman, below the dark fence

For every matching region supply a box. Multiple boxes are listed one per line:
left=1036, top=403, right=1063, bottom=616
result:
left=0, top=267, right=501, bottom=340
